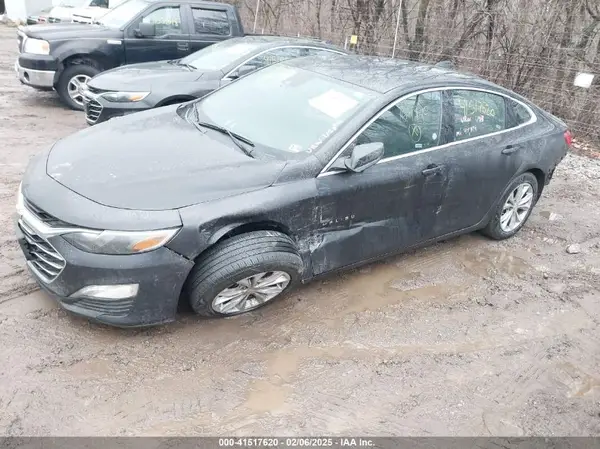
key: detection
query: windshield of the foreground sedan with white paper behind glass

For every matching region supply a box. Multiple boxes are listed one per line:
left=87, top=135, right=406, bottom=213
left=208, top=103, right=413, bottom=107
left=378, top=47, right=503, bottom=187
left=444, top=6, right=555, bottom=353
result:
left=195, top=65, right=376, bottom=158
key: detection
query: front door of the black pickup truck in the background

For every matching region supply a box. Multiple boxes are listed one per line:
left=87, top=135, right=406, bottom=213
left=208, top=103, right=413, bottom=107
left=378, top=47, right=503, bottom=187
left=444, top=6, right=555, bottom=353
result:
left=125, top=4, right=190, bottom=64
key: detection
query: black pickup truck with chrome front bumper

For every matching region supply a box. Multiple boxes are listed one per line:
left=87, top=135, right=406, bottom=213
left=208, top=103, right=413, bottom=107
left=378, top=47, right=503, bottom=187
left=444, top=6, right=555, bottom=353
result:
left=15, top=0, right=244, bottom=110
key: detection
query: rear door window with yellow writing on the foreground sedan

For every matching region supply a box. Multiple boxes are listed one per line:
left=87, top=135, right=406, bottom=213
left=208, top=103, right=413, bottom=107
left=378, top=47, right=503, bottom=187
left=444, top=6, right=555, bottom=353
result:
left=452, top=90, right=506, bottom=142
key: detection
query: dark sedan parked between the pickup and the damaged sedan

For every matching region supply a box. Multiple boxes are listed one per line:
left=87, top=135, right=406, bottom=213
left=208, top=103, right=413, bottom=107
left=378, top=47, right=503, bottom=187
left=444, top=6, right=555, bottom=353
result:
left=81, top=36, right=345, bottom=125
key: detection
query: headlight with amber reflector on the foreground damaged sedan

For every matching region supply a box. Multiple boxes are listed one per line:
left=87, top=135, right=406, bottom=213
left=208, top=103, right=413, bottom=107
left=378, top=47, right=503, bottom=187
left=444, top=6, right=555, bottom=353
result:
left=62, top=228, right=179, bottom=254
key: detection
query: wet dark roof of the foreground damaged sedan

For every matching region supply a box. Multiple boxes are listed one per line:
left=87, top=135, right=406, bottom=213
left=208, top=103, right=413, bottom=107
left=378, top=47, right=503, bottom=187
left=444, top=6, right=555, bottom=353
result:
left=284, top=55, right=491, bottom=93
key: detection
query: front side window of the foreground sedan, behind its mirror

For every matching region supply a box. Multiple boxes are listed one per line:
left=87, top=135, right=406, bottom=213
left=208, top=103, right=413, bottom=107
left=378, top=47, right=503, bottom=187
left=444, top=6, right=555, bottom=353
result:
left=356, top=92, right=442, bottom=158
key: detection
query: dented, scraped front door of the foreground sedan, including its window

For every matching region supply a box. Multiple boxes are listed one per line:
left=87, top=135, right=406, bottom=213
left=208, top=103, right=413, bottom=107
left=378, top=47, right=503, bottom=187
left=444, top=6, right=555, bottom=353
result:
left=312, top=92, right=448, bottom=275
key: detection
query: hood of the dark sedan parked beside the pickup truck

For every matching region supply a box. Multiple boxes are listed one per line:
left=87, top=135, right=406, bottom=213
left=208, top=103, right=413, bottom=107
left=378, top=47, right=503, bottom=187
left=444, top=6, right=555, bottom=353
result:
left=88, top=61, right=211, bottom=91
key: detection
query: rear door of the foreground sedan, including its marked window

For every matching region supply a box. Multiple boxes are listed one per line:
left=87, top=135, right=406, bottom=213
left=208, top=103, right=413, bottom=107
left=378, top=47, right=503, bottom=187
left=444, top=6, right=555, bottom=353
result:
left=438, top=89, right=534, bottom=234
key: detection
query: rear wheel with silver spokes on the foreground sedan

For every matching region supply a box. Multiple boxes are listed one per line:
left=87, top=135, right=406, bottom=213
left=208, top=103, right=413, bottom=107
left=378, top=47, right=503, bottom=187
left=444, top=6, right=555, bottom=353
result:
left=481, top=172, right=539, bottom=240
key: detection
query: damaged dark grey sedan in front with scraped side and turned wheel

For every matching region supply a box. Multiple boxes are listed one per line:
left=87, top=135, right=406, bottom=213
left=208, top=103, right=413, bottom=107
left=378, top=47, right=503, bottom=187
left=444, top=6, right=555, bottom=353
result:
left=12, top=56, right=571, bottom=326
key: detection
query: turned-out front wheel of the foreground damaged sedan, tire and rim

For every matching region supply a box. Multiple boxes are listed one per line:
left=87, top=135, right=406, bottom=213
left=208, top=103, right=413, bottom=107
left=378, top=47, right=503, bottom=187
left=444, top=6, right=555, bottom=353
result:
left=184, top=231, right=303, bottom=317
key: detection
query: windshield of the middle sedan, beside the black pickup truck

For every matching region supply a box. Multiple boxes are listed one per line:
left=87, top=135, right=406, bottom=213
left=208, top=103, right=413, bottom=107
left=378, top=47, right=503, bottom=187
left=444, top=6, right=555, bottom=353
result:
left=181, top=38, right=260, bottom=71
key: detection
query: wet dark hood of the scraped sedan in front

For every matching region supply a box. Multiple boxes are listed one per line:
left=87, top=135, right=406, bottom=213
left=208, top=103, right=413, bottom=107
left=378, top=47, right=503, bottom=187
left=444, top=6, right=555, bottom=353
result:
left=46, top=105, right=285, bottom=210
